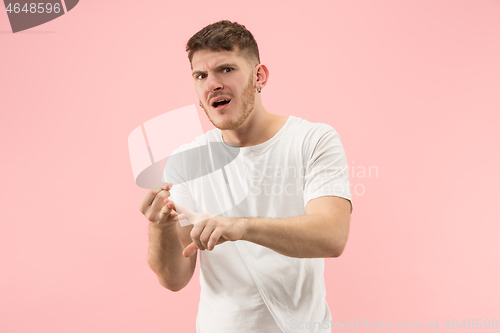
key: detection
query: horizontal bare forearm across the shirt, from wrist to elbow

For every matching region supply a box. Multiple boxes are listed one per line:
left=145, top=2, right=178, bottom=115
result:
left=243, top=214, right=346, bottom=258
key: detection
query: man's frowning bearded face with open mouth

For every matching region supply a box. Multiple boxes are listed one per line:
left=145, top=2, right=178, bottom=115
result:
left=192, top=49, right=255, bottom=130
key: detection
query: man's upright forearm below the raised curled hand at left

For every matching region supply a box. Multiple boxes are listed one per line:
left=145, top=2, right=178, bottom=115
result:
left=148, top=224, right=193, bottom=291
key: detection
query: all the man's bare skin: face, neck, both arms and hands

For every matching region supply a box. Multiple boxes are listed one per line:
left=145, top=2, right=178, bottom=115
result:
left=140, top=45, right=351, bottom=291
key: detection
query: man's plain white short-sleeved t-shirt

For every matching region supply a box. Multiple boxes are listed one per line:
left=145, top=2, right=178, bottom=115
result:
left=163, top=116, right=352, bottom=333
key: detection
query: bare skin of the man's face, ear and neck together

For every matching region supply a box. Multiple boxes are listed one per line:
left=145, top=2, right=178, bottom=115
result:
left=192, top=48, right=287, bottom=147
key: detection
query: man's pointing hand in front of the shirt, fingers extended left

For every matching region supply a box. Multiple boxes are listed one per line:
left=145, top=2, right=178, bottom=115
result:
left=175, top=203, right=246, bottom=257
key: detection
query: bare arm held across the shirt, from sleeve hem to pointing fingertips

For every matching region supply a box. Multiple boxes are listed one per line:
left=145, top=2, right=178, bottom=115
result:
left=181, top=196, right=351, bottom=258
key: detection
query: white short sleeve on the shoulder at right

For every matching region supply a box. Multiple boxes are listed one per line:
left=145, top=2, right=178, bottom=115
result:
left=304, top=127, right=353, bottom=213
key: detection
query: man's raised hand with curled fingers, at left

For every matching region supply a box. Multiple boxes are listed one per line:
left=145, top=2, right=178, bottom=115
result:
left=139, top=183, right=184, bottom=228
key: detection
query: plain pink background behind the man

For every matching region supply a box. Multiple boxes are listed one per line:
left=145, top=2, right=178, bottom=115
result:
left=0, top=0, right=500, bottom=333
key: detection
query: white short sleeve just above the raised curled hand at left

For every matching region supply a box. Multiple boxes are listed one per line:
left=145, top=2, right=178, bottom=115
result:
left=162, top=145, right=197, bottom=212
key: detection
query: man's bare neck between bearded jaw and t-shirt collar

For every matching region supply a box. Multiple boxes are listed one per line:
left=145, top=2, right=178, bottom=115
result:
left=222, top=106, right=288, bottom=147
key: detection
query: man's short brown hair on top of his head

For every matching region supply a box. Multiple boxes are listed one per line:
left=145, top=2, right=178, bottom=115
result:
left=186, top=20, right=260, bottom=67
